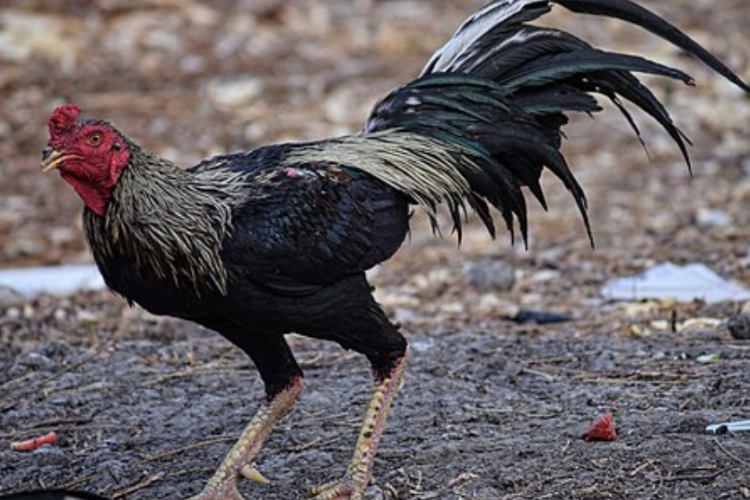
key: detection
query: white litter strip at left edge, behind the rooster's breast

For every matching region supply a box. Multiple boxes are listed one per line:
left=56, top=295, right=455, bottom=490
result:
left=0, top=265, right=105, bottom=297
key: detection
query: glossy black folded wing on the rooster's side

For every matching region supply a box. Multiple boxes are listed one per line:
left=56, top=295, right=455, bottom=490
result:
left=224, top=158, right=408, bottom=295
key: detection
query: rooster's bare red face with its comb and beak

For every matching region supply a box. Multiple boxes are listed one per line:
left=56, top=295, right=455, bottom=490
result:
left=48, top=104, right=130, bottom=216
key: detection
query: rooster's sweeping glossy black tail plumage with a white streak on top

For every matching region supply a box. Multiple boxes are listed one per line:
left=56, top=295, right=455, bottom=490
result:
left=364, top=0, right=750, bottom=245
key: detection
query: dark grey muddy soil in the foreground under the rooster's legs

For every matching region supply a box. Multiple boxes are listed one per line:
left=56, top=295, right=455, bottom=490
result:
left=0, top=297, right=750, bottom=499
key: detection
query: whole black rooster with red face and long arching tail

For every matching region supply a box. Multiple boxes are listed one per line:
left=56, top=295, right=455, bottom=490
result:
left=42, top=0, right=750, bottom=500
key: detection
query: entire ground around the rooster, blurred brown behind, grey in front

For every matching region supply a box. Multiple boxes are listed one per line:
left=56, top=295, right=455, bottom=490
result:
left=0, top=0, right=750, bottom=500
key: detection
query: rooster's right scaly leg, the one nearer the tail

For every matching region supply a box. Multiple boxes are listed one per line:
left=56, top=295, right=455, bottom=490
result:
left=312, top=350, right=409, bottom=500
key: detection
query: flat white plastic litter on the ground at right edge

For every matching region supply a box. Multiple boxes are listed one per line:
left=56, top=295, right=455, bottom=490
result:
left=600, top=262, right=750, bottom=303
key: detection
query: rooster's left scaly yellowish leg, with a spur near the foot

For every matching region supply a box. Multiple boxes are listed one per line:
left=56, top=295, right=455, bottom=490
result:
left=190, top=377, right=302, bottom=500
